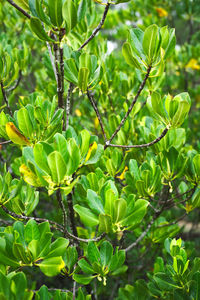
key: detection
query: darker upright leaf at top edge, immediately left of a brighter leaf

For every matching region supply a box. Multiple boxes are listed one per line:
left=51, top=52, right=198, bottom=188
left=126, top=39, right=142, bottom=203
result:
left=48, top=0, right=63, bottom=27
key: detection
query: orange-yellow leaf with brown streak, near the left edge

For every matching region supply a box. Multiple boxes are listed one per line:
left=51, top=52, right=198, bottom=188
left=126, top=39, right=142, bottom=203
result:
left=6, top=122, right=30, bottom=145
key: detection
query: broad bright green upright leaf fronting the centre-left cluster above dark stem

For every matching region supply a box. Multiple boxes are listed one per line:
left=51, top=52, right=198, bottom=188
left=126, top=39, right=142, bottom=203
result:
left=47, top=151, right=67, bottom=183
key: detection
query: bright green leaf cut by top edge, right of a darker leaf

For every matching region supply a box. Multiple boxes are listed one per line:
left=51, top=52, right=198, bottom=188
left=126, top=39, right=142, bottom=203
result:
left=62, top=0, right=77, bottom=33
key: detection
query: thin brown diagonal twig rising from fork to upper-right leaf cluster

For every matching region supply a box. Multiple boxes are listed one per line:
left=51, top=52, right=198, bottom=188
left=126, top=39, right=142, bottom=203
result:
left=104, top=65, right=151, bottom=149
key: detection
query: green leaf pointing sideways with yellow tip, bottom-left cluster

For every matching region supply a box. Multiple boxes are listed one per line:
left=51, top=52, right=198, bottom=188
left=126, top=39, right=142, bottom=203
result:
left=35, top=257, right=65, bottom=277
